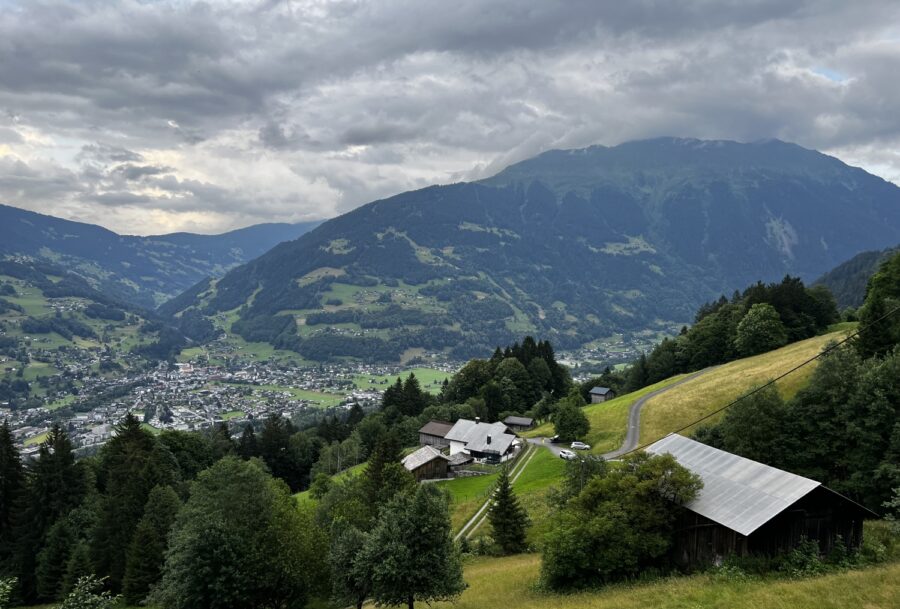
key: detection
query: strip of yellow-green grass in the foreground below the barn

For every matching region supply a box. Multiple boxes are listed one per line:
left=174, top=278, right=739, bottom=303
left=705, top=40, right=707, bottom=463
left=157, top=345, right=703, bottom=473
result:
left=408, top=554, right=900, bottom=609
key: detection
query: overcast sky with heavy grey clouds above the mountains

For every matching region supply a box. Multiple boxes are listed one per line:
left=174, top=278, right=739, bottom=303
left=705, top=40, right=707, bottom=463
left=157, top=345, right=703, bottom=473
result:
left=0, top=0, right=900, bottom=234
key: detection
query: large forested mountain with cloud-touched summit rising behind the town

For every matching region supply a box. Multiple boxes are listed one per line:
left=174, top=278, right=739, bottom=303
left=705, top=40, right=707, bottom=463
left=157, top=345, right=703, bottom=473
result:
left=161, top=138, right=900, bottom=360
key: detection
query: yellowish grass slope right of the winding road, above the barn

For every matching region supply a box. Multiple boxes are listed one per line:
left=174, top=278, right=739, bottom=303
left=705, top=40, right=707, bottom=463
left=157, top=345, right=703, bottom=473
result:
left=641, top=329, right=847, bottom=443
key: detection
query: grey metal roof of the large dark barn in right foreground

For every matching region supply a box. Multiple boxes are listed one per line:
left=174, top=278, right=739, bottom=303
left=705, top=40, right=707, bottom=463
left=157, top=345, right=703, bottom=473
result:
left=645, top=434, right=821, bottom=535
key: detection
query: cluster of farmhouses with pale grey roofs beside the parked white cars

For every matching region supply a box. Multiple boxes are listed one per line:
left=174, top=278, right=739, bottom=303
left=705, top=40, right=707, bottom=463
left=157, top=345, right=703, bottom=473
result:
left=402, top=416, right=534, bottom=481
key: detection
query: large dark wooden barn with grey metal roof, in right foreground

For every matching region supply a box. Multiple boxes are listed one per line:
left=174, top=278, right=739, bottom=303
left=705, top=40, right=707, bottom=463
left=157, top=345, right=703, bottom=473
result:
left=646, top=434, right=878, bottom=566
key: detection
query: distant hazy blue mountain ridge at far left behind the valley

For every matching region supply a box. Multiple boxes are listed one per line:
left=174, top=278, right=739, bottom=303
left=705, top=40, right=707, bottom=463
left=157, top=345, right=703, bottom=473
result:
left=0, top=205, right=320, bottom=308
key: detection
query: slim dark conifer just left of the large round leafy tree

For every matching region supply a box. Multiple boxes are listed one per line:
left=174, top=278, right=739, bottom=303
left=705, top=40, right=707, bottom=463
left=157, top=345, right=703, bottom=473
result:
left=122, top=486, right=181, bottom=605
